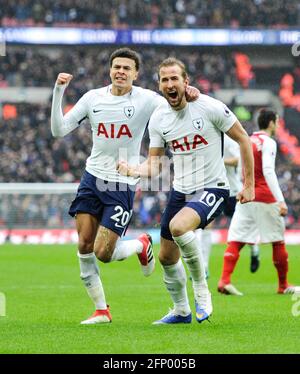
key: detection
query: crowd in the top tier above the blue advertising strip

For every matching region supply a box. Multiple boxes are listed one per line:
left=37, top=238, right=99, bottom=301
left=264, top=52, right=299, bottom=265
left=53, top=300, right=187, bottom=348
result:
left=0, top=0, right=300, bottom=28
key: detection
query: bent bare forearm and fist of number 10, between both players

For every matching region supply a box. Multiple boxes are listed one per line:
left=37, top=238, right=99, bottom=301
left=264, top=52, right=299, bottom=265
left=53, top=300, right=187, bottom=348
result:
left=117, top=148, right=165, bottom=178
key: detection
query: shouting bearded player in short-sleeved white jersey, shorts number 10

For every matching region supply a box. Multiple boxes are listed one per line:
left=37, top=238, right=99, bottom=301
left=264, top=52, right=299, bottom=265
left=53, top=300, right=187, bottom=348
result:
left=119, top=58, right=254, bottom=324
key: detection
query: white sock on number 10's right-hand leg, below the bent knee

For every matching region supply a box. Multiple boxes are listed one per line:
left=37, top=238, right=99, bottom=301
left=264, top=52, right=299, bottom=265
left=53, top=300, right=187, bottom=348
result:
left=173, top=231, right=208, bottom=300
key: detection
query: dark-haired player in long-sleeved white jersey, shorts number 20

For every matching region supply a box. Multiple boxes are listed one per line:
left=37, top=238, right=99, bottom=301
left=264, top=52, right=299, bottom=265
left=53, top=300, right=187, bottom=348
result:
left=51, top=48, right=199, bottom=324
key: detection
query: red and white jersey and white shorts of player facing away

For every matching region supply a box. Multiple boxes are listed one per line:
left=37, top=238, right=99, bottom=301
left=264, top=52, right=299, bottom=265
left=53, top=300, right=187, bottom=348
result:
left=228, top=131, right=285, bottom=243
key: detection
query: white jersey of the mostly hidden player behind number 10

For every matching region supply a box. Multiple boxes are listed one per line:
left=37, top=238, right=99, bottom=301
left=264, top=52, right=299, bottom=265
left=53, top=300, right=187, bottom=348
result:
left=224, top=135, right=243, bottom=196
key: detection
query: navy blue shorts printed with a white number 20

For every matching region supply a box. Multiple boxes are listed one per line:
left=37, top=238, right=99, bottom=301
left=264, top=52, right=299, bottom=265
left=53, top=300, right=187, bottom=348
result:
left=69, top=171, right=135, bottom=236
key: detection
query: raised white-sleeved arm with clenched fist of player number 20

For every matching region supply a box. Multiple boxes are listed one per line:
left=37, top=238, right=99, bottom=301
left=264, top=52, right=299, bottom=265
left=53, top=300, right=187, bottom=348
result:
left=51, top=73, right=87, bottom=137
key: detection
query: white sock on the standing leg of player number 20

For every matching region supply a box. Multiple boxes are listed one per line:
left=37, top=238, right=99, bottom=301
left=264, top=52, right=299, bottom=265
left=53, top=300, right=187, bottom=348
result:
left=78, top=252, right=107, bottom=310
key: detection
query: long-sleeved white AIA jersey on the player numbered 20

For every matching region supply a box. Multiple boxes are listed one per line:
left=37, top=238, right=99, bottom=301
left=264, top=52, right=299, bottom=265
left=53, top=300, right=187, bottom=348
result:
left=51, top=85, right=166, bottom=185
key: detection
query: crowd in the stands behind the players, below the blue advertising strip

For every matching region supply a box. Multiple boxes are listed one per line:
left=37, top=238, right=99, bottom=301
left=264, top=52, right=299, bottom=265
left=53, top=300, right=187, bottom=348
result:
left=0, top=45, right=300, bottom=227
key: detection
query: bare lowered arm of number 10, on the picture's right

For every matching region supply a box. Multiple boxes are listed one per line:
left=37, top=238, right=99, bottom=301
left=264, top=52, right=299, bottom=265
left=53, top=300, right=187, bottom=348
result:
left=226, top=121, right=255, bottom=204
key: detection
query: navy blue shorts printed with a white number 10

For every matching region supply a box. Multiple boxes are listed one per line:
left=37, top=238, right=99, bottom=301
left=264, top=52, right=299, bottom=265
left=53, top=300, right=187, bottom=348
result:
left=161, top=188, right=229, bottom=240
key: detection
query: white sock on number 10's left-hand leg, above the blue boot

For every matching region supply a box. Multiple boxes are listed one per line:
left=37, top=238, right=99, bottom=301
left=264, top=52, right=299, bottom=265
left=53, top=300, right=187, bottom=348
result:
left=162, top=259, right=191, bottom=316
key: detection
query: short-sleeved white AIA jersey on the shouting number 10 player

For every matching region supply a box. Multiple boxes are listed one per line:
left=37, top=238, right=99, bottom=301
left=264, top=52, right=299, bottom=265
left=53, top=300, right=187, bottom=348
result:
left=149, top=94, right=237, bottom=194
